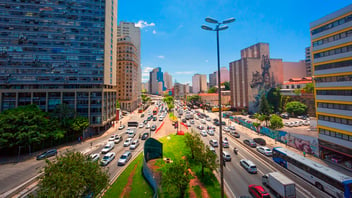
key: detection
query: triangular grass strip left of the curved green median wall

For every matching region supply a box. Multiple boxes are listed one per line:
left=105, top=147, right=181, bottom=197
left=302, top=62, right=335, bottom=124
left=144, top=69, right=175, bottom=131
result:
left=104, top=153, right=153, bottom=198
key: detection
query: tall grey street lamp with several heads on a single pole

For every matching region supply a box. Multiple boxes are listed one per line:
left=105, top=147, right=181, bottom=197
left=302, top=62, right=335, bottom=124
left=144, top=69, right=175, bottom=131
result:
left=202, top=17, right=236, bottom=198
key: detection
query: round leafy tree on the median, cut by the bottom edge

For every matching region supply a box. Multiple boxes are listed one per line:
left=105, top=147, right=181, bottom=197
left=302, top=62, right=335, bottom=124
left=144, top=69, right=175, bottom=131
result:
left=161, top=160, right=192, bottom=197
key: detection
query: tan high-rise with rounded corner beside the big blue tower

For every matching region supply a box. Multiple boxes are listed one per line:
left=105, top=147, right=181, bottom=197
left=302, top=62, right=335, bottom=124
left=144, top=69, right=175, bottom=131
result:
left=116, top=36, right=141, bottom=112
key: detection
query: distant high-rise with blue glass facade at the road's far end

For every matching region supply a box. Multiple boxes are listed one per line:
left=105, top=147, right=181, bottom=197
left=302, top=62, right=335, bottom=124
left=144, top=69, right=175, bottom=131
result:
left=149, top=67, right=166, bottom=95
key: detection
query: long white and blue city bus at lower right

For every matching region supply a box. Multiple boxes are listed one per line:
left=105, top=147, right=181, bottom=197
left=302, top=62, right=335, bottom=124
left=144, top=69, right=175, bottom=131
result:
left=273, top=147, right=352, bottom=198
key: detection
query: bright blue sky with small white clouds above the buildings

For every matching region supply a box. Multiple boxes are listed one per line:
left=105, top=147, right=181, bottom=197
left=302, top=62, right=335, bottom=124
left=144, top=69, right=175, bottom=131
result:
left=118, top=0, right=351, bottom=84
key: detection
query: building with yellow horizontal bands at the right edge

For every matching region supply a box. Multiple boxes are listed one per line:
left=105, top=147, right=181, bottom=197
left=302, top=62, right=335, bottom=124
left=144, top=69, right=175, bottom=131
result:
left=310, top=5, right=352, bottom=168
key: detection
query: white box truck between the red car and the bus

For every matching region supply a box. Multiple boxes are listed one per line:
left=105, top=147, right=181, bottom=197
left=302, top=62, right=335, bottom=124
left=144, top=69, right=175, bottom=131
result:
left=262, top=172, right=296, bottom=198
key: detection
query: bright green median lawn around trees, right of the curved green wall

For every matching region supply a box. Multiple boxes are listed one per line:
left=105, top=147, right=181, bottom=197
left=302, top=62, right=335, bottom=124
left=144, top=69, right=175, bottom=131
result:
left=156, top=135, right=224, bottom=198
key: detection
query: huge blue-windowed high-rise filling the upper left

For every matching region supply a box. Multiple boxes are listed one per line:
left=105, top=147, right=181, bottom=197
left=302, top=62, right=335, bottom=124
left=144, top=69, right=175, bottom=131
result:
left=0, top=0, right=118, bottom=132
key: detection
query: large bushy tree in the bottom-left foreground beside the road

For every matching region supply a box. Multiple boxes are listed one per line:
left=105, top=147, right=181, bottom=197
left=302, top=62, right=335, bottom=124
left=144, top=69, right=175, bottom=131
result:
left=37, top=152, right=109, bottom=197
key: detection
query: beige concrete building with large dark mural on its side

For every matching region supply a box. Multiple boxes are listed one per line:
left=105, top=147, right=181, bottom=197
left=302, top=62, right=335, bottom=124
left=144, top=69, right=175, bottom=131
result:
left=230, top=43, right=283, bottom=113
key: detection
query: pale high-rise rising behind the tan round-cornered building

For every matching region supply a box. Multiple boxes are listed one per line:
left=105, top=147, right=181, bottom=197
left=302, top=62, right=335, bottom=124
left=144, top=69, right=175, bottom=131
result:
left=117, top=21, right=142, bottom=103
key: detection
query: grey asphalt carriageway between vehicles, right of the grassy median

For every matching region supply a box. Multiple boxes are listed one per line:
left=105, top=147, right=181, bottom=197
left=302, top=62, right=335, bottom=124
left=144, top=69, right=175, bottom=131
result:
left=187, top=110, right=330, bottom=198
